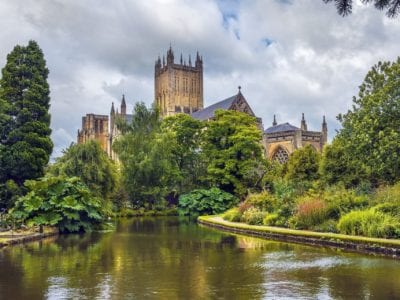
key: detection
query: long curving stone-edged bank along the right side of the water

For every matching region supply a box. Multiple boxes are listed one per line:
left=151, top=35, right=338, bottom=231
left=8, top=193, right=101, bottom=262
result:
left=197, top=216, right=400, bottom=258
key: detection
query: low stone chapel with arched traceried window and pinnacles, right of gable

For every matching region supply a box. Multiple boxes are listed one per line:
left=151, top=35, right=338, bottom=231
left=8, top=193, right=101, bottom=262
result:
left=264, top=114, right=328, bottom=163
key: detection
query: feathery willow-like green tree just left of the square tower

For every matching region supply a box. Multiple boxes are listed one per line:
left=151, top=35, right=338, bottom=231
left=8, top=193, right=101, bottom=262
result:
left=113, top=103, right=179, bottom=208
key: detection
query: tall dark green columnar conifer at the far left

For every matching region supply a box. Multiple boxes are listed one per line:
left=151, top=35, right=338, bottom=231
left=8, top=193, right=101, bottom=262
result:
left=0, top=41, right=53, bottom=186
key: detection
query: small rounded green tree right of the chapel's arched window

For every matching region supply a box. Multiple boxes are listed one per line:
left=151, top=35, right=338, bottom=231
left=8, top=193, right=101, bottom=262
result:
left=286, top=145, right=320, bottom=182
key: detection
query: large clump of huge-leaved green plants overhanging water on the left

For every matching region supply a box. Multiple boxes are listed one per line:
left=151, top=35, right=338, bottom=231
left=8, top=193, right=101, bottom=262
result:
left=11, top=176, right=105, bottom=232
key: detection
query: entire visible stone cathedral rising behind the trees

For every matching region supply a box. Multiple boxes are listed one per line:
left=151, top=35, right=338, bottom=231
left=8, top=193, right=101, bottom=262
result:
left=77, top=47, right=328, bottom=163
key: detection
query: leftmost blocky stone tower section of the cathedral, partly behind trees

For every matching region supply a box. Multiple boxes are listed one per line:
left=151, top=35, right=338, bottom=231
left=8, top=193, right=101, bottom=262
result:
left=77, top=114, right=109, bottom=152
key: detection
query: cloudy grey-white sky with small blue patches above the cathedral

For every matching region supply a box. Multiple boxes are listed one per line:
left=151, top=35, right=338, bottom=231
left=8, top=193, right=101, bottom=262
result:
left=0, top=0, right=400, bottom=157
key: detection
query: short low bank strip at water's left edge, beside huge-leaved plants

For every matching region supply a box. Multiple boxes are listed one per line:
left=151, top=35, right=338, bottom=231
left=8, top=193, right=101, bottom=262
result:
left=0, top=227, right=59, bottom=248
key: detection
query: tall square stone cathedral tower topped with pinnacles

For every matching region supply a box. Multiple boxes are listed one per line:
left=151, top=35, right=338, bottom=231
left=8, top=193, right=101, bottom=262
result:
left=154, top=47, right=203, bottom=117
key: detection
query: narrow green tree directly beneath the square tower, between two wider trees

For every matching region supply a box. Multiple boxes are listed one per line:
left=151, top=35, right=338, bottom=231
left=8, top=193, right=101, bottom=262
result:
left=161, top=114, right=205, bottom=194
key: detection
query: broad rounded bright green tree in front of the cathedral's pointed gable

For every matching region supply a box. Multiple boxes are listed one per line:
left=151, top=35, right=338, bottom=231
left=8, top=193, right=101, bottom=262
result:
left=203, top=110, right=265, bottom=197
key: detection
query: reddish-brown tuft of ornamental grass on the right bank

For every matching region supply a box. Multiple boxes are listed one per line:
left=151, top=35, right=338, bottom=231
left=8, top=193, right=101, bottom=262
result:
left=294, top=198, right=328, bottom=229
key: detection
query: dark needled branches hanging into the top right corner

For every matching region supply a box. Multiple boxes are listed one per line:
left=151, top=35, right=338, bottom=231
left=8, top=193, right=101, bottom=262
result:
left=322, top=0, right=400, bottom=18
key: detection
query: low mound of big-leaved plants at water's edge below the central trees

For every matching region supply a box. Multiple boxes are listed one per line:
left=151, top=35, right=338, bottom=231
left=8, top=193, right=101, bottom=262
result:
left=178, top=187, right=238, bottom=215
